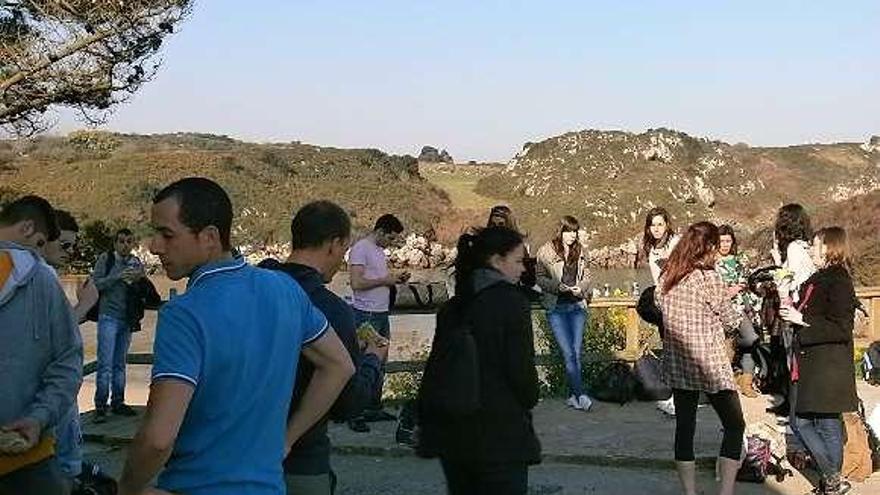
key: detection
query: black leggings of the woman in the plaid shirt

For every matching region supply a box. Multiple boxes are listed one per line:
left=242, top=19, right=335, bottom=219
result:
left=672, top=388, right=746, bottom=461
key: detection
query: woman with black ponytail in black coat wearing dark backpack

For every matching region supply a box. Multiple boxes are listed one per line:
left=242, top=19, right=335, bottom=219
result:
left=418, top=227, right=541, bottom=495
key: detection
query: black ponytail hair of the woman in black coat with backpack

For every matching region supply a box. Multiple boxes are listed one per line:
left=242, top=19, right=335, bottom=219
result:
left=455, top=227, right=523, bottom=300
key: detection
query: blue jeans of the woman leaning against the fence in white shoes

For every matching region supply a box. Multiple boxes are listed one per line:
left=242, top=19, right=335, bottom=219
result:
left=547, top=303, right=587, bottom=397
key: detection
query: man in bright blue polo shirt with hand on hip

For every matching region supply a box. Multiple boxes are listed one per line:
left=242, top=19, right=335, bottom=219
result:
left=119, top=178, right=354, bottom=495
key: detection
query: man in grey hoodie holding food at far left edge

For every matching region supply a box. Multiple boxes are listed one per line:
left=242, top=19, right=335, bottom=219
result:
left=0, top=196, right=83, bottom=495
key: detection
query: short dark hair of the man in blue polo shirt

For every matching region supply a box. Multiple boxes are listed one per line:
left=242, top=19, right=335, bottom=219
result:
left=153, top=177, right=232, bottom=250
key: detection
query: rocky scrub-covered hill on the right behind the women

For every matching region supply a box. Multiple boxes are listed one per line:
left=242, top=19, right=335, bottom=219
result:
left=475, top=129, right=880, bottom=250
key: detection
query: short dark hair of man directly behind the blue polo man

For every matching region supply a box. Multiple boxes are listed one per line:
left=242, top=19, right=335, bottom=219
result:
left=290, top=201, right=351, bottom=249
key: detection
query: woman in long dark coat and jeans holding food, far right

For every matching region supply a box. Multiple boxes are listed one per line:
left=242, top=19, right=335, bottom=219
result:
left=780, top=227, right=858, bottom=494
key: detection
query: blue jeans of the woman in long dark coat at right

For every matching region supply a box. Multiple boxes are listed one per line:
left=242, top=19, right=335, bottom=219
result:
left=792, top=416, right=843, bottom=479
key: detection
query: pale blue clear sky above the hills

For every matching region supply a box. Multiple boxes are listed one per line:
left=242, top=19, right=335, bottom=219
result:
left=56, top=0, right=880, bottom=161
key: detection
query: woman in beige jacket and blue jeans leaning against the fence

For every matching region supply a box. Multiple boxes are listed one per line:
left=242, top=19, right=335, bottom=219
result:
left=537, top=216, right=593, bottom=411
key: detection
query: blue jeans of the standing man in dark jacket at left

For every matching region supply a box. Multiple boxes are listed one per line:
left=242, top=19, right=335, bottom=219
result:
left=95, top=315, right=131, bottom=409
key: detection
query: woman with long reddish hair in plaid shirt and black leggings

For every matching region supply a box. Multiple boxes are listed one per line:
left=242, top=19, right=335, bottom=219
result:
left=655, top=222, right=745, bottom=495
